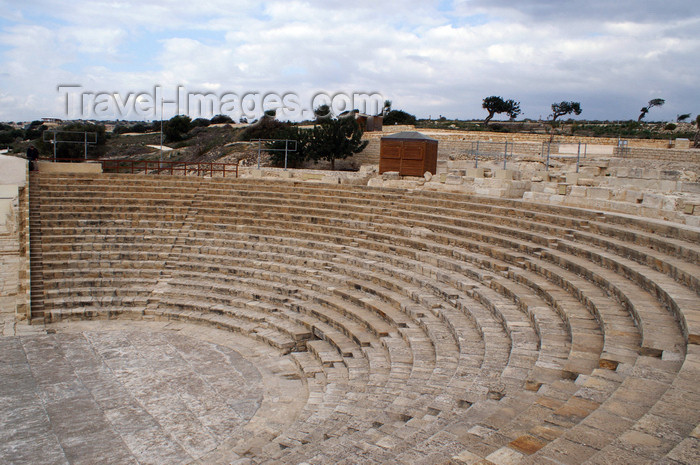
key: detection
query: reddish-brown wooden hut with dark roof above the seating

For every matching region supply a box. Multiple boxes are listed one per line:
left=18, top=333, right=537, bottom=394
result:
left=379, top=131, right=438, bottom=176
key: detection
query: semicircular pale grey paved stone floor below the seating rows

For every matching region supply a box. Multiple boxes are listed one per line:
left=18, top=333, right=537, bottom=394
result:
left=0, top=321, right=307, bottom=464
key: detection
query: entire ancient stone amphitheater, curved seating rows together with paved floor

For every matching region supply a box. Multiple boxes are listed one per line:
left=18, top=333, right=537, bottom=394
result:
left=0, top=152, right=700, bottom=465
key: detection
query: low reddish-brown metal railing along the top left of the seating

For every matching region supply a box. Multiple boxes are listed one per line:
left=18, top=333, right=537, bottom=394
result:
left=42, top=158, right=238, bottom=178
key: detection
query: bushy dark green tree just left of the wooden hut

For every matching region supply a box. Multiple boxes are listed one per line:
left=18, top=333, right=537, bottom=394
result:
left=308, top=110, right=369, bottom=170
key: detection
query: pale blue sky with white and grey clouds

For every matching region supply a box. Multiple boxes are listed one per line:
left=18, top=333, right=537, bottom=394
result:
left=0, top=0, right=700, bottom=121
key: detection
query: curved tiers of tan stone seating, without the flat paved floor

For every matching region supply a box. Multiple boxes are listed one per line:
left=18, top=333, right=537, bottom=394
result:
left=31, top=175, right=700, bottom=464
